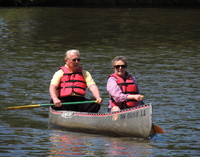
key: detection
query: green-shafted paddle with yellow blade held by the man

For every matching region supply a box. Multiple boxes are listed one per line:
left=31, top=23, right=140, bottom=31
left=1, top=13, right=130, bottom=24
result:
left=4, top=100, right=97, bottom=110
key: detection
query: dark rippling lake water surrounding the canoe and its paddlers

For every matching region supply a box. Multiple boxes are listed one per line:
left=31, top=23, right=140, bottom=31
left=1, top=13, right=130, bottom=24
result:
left=0, top=7, right=200, bottom=156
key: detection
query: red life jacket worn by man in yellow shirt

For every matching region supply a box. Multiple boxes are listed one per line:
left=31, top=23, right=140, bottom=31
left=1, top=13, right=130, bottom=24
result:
left=57, top=66, right=87, bottom=97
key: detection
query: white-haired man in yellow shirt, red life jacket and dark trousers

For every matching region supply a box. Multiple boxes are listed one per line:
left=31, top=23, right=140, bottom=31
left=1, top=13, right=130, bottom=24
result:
left=49, top=50, right=102, bottom=112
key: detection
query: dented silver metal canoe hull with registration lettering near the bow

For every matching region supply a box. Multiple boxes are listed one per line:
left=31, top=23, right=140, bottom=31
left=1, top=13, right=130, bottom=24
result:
left=49, top=104, right=152, bottom=139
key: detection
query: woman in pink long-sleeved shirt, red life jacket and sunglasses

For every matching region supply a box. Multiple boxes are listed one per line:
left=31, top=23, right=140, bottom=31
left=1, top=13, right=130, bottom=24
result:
left=107, top=56, right=143, bottom=112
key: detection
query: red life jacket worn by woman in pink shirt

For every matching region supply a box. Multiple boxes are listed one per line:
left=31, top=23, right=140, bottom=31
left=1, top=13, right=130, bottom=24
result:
left=110, top=73, right=138, bottom=109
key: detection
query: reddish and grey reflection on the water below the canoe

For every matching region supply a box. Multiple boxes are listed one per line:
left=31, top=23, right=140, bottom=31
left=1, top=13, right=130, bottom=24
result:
left=50, top=130, right=152, bottom=156
